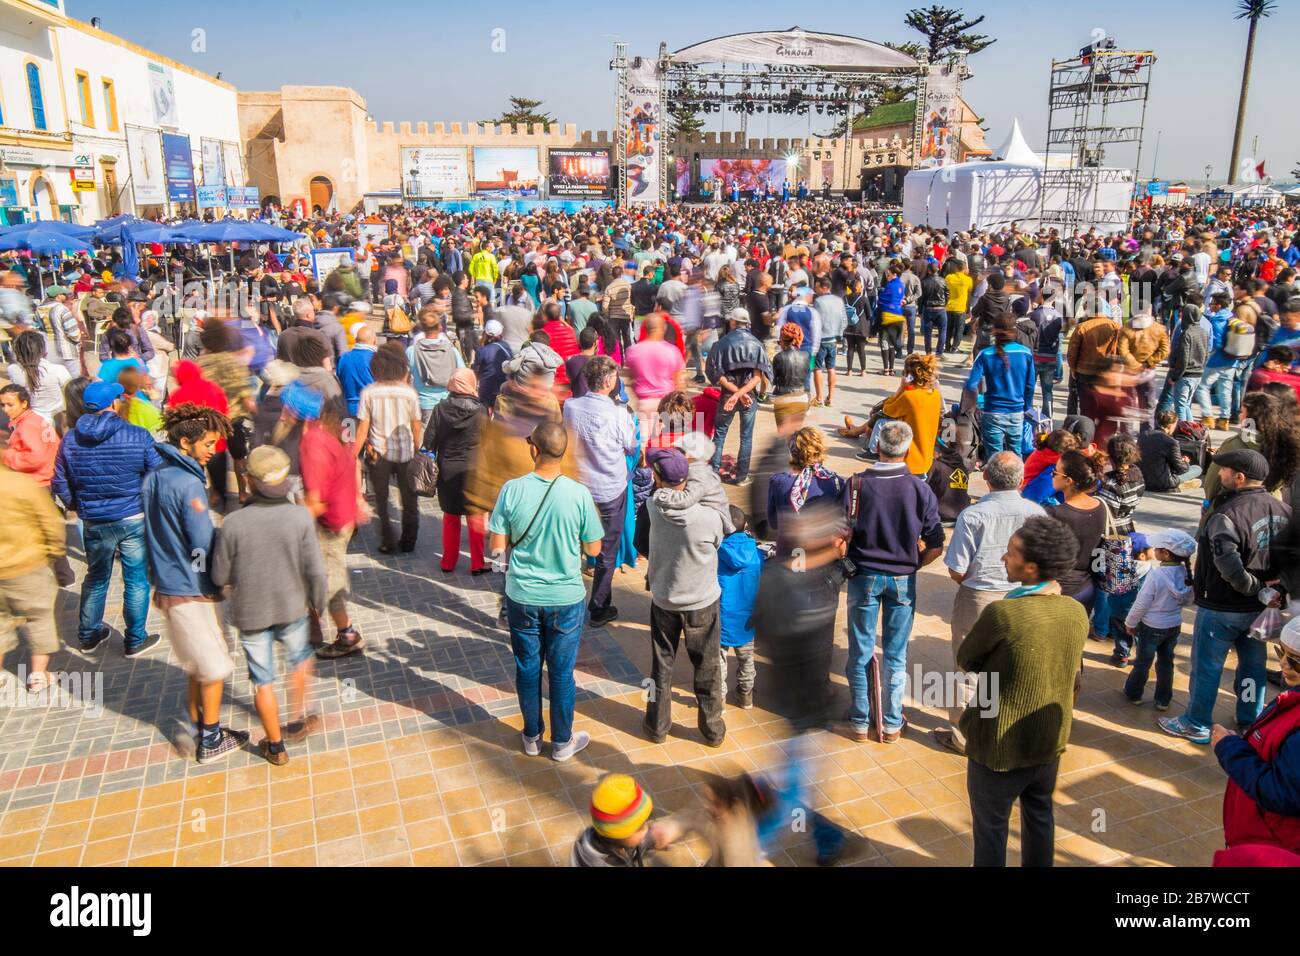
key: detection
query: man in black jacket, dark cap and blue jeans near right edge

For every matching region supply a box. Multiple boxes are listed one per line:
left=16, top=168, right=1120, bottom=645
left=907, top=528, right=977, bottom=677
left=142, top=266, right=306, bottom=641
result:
left=1160, top=449, right=1291, bottom=744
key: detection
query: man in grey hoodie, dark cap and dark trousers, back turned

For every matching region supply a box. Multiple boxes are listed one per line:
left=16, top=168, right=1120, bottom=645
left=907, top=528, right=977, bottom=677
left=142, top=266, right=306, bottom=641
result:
left=634, top=449, right=727, bottom=747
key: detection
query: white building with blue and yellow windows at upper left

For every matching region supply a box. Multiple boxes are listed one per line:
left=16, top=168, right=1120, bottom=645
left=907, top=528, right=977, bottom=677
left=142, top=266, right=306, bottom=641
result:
left=0, top=0, right=246, bottom=222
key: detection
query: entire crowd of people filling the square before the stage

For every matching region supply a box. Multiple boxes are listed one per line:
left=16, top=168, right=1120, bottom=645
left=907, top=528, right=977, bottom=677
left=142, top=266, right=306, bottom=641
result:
left=0, top=198, right=1300, bottom=866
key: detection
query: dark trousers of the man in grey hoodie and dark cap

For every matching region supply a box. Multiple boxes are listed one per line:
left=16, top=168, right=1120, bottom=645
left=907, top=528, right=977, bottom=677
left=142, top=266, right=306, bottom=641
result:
left=645, top=601, right=727, bottom=744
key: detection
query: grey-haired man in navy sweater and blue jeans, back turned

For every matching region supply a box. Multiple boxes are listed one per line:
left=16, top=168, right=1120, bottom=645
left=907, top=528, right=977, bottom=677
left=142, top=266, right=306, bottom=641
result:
left=845, top=421, right=944, bottom=744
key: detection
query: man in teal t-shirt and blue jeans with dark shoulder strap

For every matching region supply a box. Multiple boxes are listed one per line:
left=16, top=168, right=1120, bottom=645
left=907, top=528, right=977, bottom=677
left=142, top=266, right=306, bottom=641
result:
left=488, top=421, right=605, bottom=761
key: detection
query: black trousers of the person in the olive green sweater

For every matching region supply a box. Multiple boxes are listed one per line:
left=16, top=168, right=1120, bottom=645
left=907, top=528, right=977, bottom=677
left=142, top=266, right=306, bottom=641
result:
left=966, top=757, right=1061, bottom=866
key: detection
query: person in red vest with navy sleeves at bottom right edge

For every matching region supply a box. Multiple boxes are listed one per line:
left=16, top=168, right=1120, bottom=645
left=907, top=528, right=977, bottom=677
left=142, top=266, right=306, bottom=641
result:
left=1210, top=618, right=1300, bottom=866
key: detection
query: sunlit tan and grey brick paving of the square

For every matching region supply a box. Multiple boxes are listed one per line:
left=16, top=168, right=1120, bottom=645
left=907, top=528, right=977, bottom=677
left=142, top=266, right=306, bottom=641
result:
left=0, top=368, right=1230, bottom=866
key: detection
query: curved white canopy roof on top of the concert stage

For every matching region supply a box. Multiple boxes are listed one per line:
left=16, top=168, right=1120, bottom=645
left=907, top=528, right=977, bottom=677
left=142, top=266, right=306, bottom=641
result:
left=671, top=26, right=919, bottom=73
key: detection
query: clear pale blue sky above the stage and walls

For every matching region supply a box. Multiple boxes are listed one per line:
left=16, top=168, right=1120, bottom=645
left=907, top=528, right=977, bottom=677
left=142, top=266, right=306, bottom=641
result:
left=66, top=0, right=1300, bottom=182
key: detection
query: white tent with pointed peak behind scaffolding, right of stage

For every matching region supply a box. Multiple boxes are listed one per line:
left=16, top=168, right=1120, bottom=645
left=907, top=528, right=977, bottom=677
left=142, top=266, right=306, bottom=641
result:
left=902, top=121, right=1132, bottom=232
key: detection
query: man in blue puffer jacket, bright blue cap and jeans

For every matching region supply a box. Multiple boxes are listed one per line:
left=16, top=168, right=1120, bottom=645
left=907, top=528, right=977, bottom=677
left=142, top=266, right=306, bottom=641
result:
left=51, top=381, right=163, bottom=657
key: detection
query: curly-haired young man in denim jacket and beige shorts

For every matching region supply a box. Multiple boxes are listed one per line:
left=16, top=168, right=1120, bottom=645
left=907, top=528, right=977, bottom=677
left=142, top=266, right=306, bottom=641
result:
left=140, top=402, right=248, bottom=763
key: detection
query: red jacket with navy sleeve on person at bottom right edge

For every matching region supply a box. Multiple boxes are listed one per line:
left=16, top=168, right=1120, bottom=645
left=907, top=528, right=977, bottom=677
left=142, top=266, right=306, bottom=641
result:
left=1214, top=688, right=1300, bottom=852
